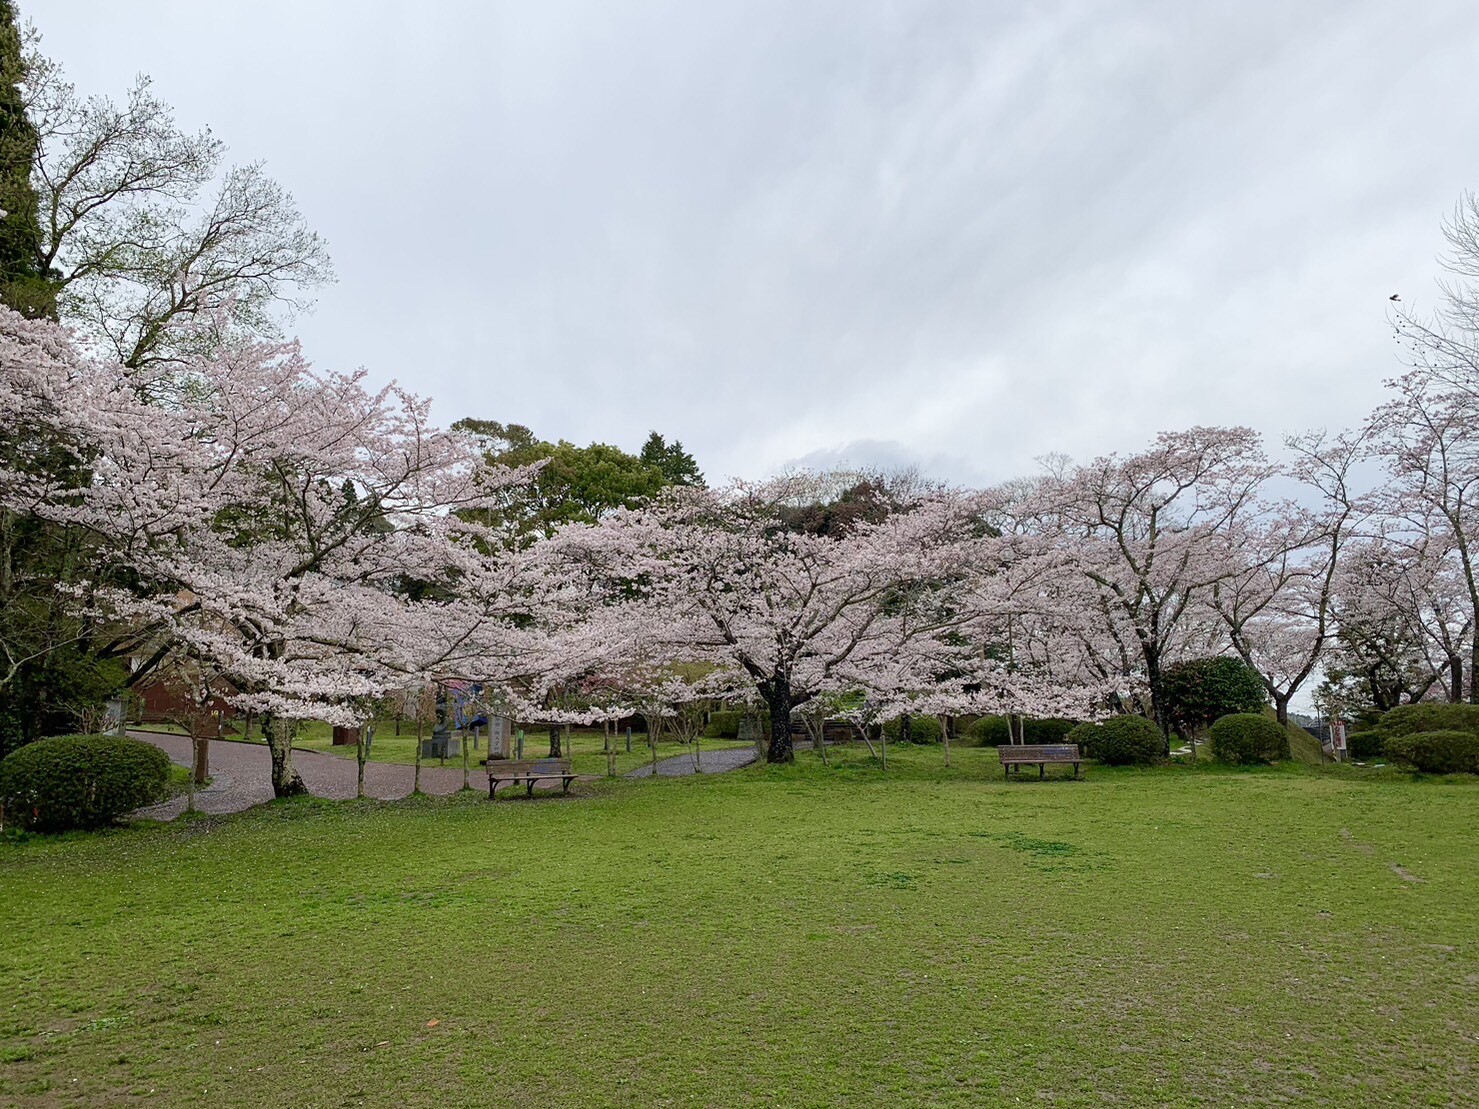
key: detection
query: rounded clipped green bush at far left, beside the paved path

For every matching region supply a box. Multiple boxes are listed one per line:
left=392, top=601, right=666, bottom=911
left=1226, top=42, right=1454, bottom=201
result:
left=0, top=735, right=170, bottom=832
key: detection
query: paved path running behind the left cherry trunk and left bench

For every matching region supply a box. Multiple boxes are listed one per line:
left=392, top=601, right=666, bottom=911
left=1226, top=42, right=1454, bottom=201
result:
left=129, top=732, right=754, bottom=821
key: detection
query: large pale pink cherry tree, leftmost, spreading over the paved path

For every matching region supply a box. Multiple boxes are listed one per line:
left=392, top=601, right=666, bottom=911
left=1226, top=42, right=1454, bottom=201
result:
left=0, top=315, right=527, bottom=796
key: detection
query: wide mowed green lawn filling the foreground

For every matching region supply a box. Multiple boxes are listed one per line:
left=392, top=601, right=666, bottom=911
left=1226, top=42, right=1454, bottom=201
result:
left=0, top=748, right=1479, bottom=1108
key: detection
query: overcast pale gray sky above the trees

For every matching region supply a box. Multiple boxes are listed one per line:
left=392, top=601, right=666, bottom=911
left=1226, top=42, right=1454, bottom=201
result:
left=21, top=0, right=1479, bottom=482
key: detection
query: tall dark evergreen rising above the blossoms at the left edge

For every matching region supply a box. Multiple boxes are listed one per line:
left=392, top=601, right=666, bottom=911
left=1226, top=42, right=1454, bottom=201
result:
left=0, top=0, right=56, bottom=319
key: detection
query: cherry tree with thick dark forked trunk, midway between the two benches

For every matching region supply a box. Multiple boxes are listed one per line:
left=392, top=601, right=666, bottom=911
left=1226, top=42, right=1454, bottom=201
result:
left=556, top=475, right=993, bottom=762
